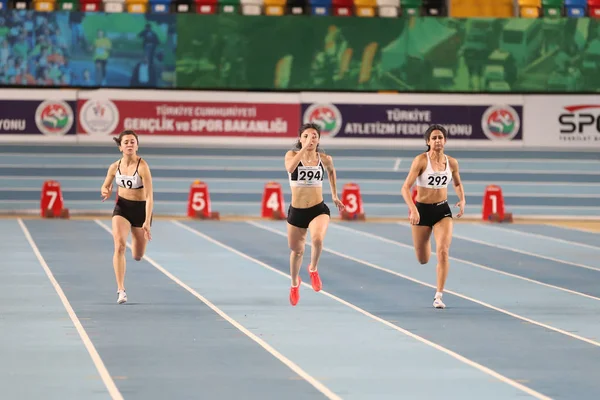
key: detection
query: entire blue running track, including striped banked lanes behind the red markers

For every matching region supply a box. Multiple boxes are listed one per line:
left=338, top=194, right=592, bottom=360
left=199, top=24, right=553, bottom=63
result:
left=0, top=145, right=600, bottom=400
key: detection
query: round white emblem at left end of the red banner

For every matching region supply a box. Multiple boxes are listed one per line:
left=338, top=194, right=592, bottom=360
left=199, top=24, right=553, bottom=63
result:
left=79, top=99, right=119, bottom=135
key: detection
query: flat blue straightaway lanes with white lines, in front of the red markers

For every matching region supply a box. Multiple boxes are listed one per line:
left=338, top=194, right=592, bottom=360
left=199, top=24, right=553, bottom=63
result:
left=0, top=217, right=600, bottom=400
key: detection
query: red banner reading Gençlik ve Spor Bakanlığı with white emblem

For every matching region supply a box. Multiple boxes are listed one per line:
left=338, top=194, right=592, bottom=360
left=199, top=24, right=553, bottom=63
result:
left=78, top=90, right=300, bottom=140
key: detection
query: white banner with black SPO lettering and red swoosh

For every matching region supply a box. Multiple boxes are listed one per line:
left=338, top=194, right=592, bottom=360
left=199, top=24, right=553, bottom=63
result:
left=525, top=95, right=600, bottom=149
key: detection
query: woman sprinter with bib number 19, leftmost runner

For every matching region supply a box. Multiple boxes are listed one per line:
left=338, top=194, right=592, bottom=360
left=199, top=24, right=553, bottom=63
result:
left=100, top=131, right=154, bottom=304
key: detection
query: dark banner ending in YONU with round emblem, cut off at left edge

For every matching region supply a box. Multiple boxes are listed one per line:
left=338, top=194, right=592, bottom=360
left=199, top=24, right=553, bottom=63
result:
left=0, top=89, right=77, bottom=137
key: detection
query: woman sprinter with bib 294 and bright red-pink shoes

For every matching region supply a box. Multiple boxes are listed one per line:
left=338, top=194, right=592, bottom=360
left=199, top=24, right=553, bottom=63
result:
left=285, top=123, right=344, bottom=306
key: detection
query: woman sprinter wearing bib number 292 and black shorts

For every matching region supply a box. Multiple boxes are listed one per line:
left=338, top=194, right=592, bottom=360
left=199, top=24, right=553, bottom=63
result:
left=402, top=125, right=466, bottom=308
